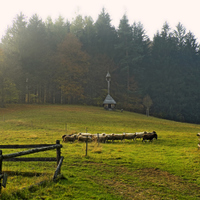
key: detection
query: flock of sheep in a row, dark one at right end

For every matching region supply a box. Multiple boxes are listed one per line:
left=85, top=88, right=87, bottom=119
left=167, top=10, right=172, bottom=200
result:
left=62, top=131, right=158, bottom=143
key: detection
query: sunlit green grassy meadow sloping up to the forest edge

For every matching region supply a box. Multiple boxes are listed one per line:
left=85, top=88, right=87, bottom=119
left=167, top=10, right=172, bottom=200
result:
left=0, top=105, right=200, bottom=200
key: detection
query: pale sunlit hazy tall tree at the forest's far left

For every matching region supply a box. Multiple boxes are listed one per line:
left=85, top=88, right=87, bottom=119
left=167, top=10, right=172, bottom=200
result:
left=2, top=13, right=27, bottom=102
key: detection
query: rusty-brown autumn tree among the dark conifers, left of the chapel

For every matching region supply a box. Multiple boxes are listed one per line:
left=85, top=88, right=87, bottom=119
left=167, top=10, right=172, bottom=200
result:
left=54, top=33, right=89, bottom=103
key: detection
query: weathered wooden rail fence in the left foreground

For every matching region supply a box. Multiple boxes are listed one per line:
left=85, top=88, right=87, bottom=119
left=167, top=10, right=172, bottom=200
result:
left=0, top=140, right=64, bottom=192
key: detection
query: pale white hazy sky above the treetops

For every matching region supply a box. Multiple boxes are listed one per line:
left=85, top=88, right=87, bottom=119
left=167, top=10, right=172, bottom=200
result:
left=0, top=0, right=200, bottom=42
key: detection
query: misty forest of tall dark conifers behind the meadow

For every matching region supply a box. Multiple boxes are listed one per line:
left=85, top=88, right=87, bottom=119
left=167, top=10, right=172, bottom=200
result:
left=0, top=9, right=200, bottom=123
